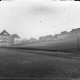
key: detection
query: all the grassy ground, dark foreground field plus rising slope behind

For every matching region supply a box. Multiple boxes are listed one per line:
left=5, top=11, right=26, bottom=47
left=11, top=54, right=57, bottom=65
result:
left=0, top=37, right=80, bottom=80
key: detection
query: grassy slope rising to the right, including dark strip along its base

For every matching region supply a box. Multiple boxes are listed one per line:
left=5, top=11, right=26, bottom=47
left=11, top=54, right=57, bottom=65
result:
left=8, top=37, right=80, bottom=53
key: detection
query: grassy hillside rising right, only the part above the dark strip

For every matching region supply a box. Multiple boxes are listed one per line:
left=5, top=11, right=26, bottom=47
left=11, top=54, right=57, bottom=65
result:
left=27, top=38, right=79, bottom=52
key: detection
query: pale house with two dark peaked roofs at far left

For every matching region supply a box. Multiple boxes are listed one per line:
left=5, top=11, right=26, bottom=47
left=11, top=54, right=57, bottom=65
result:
left=0, top=30, right=20, bottom=46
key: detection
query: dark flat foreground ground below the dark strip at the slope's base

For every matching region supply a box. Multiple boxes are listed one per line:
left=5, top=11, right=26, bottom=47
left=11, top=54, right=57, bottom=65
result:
left=0, top=48, right=80, bottom=80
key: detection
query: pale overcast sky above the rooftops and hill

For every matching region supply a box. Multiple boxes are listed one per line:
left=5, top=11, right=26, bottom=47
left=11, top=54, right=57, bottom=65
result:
left=0, top=0, right=80, bottom=39
